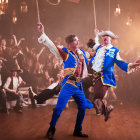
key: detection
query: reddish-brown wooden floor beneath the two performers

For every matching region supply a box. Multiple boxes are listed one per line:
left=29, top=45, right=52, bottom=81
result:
left=0, top=102, right=140, bottom=140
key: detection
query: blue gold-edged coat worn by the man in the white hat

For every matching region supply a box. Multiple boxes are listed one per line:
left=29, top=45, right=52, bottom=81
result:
left=89, top=45, right=129, bottom=86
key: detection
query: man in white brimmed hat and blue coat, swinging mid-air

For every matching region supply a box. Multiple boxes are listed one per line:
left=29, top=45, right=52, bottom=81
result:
left=88, top=30, right=140, bottom=121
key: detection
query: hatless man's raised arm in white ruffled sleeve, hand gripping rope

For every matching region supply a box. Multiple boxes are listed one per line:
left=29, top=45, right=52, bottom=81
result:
left=38, top=23, right=67, bottom=60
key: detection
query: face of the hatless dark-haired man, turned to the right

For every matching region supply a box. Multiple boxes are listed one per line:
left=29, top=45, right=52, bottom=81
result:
left=68, top=36, right=79, bottom=50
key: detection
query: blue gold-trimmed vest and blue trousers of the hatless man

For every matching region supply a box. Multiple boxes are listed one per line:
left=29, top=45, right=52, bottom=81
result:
left=50, top=48, right=93, bottom=131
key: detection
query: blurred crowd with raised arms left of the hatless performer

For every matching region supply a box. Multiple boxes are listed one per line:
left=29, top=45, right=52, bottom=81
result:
left=0, top=35, right=63, bottom=91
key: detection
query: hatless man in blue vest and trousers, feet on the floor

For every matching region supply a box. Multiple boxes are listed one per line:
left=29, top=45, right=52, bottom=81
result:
left=38, top=24, right=93, bottom=139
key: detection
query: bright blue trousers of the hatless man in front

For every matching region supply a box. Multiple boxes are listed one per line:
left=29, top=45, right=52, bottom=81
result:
left=50, top=83, right=93, bottom=131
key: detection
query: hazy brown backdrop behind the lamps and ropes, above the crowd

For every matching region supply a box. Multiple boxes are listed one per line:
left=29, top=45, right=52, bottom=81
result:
left=0, top=0, right=140, bottom=49
